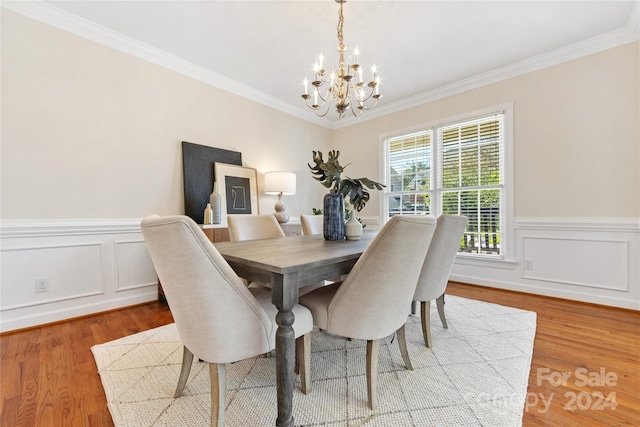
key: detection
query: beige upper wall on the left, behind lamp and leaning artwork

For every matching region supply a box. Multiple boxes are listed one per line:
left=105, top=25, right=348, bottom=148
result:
left=0, top=9, right=332, bottom=219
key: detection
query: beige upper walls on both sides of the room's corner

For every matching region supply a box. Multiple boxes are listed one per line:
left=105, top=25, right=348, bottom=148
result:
left=0, top=10, right=640, bottom=224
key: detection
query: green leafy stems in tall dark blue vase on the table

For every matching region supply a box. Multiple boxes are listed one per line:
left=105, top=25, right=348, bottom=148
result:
left=307, top=150, right=385, bottom=240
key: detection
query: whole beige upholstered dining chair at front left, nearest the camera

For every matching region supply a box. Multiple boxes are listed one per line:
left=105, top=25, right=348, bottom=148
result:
left=141, top=215, right=313, bottom=426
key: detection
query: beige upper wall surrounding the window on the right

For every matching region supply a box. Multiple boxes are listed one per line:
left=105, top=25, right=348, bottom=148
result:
left=334, top=42, right=640, bottom=218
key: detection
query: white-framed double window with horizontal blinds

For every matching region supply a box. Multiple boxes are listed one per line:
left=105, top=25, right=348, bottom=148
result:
left=383, top=105, right=510, bottom=258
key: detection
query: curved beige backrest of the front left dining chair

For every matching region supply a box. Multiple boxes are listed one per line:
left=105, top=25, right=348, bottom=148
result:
left=141, top=215, right=273, bottom=363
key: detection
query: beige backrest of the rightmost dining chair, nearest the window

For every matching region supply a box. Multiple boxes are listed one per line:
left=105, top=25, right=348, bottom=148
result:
left=413, top=215, right=467, bottom=301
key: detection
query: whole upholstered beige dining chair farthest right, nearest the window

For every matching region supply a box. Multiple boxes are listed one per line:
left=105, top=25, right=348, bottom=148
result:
left=413, top=215, right=467, bottom=348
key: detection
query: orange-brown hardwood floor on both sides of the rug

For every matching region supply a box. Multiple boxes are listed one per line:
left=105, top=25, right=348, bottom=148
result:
left=0, top=283, right=640, bottom=427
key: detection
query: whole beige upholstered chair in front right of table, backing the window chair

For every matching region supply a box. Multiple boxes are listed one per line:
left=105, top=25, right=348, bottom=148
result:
left=300, top=215, right=436, bottom=410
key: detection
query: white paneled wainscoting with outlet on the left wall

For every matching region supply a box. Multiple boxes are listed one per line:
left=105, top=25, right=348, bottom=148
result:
left=0, top=219, right=158, bottom=332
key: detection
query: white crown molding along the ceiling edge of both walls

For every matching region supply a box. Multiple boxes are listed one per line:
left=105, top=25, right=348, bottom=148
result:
left=0, top=0, right=640, bottom=129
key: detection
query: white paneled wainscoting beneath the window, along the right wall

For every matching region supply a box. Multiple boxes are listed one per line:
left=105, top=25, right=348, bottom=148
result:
left=451, top=218, right=640, bottom=310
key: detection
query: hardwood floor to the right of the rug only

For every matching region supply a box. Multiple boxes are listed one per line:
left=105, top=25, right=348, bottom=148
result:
left=445, top=283, right=640, bottom=427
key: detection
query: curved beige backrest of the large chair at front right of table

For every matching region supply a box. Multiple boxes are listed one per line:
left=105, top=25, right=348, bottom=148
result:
left=327, top=215, right=436, bottom=340
